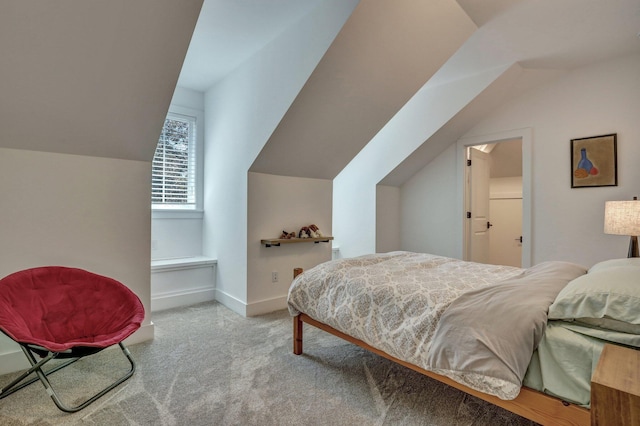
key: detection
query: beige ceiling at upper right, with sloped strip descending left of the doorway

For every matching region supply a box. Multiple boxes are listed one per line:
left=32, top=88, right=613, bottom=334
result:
left=378, top=0, right=640, bottom=186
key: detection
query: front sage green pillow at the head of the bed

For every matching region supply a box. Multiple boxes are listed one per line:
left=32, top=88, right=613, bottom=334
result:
left=548, top=259, right=640, bottom=335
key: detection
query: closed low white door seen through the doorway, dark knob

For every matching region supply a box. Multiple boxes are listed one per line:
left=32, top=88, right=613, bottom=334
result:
left=489, top=198, right=522, bottom=267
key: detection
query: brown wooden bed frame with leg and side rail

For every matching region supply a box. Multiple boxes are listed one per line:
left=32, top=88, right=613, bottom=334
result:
left=293, top=268, right=591, bottom=426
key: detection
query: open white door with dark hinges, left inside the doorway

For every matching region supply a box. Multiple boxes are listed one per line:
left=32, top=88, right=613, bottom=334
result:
left=468, top=148, right=491, bottom=263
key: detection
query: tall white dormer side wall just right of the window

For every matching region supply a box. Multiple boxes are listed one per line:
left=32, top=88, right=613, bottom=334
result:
left=203, top=0, right=357, bottom=315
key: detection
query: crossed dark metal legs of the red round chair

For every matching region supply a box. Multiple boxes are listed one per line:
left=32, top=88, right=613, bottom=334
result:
left=0, top=342, right=136, bottom=413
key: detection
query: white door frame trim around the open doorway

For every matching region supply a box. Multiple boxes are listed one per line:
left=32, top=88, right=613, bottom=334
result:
left=456, top=127, right=533, bottom=268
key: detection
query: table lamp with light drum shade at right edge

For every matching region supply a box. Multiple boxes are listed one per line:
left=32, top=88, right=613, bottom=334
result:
left=604, top=197, right=640, bottom=257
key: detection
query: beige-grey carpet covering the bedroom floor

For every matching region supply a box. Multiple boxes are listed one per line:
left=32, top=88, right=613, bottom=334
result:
left=0, top=302, right=533, bottom=426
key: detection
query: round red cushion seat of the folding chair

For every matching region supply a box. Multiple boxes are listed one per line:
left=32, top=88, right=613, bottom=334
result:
left=0, top=266, right=144, bottom=352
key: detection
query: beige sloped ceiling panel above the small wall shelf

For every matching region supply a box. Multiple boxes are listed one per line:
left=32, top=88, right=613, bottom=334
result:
left=251, top=0, right=476, bottom=179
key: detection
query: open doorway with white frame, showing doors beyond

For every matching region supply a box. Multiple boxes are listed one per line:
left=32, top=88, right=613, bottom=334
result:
left=458, top=129, right=531, bottom=267
